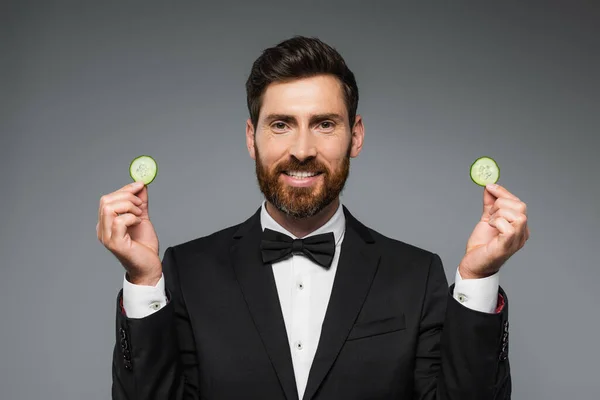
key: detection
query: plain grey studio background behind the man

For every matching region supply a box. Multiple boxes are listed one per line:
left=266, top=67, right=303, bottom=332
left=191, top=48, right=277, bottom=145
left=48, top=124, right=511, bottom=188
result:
left=0, top=1, right=600, bottom=400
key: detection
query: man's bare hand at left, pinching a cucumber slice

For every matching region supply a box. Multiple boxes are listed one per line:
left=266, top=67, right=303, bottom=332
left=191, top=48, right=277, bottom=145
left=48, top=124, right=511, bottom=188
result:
left=96, top=182, right=162, bottom=286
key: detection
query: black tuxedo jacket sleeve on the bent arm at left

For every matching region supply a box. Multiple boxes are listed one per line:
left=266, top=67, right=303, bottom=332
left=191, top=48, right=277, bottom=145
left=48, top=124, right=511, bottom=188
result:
left=112, top=247, right=200, bottom=400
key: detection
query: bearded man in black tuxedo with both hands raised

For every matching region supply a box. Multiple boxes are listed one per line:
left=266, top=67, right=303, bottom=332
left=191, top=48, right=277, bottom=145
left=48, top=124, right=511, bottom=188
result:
left=97, top=36, right=529, bottom=400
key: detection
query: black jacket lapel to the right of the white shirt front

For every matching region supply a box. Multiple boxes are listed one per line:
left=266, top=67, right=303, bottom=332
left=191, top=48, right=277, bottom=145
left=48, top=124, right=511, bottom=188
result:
left=303, top=207, right=379, bottom=400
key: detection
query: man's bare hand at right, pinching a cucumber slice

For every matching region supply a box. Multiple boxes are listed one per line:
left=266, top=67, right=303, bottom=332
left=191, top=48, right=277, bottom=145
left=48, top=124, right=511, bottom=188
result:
left=458, top=185, right=529, bottom=279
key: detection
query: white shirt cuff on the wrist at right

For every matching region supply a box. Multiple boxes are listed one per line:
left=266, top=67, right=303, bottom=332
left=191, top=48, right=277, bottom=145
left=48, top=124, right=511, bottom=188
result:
left=452, top=268, right=500, bottom=314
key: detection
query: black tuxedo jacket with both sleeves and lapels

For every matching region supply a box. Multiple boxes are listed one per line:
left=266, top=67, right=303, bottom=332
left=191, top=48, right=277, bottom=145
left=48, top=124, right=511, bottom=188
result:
left=112, top=207, right=511, bottom=400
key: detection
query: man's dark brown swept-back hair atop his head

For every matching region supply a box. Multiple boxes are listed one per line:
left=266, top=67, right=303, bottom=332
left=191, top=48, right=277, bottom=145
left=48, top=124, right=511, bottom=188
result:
left=246, top=35, right=358, bottom=129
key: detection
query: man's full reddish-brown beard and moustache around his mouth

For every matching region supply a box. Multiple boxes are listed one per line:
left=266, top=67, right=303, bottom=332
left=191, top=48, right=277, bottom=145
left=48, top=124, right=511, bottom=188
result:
left=254, top=143, right=352, bottom=218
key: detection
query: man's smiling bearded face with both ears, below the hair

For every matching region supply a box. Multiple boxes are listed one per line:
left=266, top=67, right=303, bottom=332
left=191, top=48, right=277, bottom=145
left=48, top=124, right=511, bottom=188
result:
left=246, top=75, right=363, bottom=218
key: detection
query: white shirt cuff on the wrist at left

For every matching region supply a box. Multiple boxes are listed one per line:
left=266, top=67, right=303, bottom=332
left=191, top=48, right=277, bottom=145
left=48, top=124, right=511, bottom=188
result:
left=123, top=274, right=167, bottom=318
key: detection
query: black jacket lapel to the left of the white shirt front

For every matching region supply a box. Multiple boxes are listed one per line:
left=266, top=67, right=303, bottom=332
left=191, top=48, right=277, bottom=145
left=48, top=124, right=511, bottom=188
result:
left=231, top=209, right=298, bottom=400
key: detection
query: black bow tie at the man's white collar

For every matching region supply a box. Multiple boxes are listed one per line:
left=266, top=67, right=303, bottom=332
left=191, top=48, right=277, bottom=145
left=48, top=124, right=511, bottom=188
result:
left=260, top=229, right=335, bottom=269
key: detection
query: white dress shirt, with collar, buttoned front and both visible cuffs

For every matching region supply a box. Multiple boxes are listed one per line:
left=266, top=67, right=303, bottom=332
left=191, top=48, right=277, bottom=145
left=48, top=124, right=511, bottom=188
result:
left=123, top=201, right=499, bottom=398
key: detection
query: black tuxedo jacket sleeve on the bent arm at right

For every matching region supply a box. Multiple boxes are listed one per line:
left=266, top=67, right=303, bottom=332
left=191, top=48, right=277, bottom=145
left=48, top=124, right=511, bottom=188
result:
left=414, top=254, right=511, bottom=400
